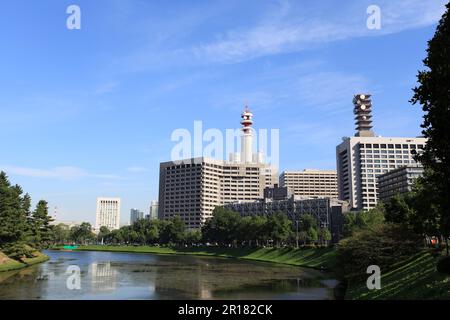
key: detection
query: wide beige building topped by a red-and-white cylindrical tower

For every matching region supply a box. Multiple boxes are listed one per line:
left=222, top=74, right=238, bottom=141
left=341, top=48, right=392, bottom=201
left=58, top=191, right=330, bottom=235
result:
left=158, top=109, right=278, bottom=229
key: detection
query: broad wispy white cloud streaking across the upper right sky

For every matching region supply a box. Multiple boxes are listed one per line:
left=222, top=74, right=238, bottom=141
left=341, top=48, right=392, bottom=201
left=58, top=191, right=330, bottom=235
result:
left=192, top=0, right=446, bottom=63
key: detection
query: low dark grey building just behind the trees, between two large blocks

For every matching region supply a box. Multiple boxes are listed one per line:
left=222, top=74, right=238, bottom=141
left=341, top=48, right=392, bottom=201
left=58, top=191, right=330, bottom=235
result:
left=225, top=186, right=349, bottom=242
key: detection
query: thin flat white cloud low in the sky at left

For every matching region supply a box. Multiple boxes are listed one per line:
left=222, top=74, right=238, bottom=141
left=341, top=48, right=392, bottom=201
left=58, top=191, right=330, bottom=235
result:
left=0, top=165, right=122, bottom=180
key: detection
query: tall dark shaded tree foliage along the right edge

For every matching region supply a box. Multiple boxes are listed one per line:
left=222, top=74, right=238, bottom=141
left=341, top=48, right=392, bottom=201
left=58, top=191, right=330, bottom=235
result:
left=411, top=3, right=450, bottom=252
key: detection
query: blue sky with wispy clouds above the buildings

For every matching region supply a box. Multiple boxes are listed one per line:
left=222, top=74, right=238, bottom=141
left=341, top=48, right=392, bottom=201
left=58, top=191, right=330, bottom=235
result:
left=0, top=0, right=446, bottom=222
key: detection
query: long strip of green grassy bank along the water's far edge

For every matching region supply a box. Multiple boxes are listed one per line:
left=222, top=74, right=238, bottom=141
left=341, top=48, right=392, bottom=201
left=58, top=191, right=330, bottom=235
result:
left=64, top=246, right=336, bottom=270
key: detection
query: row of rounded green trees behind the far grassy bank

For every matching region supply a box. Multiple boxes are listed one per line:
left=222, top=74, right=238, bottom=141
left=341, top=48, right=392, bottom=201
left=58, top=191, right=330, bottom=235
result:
left=53, top=207, right=331, bottom=248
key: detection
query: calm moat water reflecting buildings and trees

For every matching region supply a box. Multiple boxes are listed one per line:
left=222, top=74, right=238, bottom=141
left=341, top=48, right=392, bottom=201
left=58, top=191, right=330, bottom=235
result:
left=0, top=251, right=336, bottom=300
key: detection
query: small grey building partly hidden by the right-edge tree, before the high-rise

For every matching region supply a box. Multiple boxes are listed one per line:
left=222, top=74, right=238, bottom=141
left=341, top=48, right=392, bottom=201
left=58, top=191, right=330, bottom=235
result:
left=378, top=165, right=423, bottom=201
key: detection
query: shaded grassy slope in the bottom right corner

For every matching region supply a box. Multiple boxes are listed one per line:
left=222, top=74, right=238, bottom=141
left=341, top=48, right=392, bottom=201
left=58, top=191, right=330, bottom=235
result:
left=346, top=251, right=450, bottom=300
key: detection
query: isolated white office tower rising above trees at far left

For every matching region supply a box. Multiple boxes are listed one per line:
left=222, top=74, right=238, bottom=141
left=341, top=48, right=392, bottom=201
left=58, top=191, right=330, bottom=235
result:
left=95, top=198, right=120, bottom=231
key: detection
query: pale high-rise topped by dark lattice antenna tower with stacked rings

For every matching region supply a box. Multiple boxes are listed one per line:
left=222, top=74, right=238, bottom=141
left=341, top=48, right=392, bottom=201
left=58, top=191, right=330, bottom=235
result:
left=336, top=94, right=426, bottom=210
